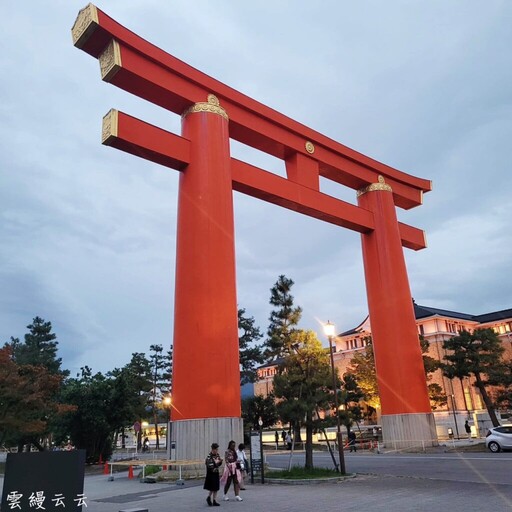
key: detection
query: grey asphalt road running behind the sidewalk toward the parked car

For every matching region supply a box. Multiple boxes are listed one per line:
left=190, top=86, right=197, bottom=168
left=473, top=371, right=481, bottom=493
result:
left=267, top=452, right=512, bottom=486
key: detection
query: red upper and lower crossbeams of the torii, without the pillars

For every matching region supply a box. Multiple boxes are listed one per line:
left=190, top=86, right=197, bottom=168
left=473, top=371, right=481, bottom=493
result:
left=72, top=4, right=432, bottom=249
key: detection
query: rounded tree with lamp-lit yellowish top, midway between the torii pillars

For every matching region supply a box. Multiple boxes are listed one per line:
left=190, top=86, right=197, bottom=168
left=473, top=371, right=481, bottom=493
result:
left=274, top=330, right=332, bottom=469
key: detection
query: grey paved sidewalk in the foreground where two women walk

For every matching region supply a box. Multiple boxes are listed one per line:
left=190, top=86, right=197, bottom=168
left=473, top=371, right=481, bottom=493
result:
left=78, top=468, right=512, bottom=512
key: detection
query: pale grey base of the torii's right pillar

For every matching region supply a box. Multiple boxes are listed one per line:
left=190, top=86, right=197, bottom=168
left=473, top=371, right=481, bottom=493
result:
left=381, top=413, right=438, bottom=450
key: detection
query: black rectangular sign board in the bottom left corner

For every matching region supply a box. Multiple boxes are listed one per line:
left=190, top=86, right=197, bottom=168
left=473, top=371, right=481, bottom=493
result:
left=1, top=450, right=87, bottom=512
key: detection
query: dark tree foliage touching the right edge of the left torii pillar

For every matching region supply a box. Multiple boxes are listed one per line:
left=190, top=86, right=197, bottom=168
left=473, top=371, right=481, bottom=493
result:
left=238, top=309, right=264, bottom=385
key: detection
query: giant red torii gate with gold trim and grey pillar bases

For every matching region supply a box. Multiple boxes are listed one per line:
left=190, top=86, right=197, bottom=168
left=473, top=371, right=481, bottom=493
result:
left=72, top=4, right=436, bottom=459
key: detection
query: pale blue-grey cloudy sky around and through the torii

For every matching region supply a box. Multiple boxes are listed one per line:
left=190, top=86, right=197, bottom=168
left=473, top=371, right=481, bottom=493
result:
left=0, top=0, right=512, bottom=374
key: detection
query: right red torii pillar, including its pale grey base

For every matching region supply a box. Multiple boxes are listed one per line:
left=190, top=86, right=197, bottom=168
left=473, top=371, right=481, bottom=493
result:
left=357, top=176, right=437, bottom=448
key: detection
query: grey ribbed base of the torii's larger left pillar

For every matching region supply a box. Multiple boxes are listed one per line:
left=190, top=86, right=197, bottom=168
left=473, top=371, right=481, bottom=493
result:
left=171, top=418, right=244, bottom=460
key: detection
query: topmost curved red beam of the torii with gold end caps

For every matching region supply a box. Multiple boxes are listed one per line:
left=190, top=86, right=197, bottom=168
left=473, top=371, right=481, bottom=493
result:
left=72, top=4, right=432, bottom=209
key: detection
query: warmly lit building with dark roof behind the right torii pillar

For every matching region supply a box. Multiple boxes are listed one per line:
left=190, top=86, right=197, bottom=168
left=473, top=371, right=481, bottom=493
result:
left=254, top=303, right=512, bottom=438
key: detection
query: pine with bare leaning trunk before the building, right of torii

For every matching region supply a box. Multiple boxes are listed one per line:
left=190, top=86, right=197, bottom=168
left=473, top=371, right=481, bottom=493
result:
left=442, top=329, right=504, bottom=427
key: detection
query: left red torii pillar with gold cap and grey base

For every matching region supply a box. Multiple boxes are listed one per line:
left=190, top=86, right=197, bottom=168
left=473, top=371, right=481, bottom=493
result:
left=171, top=95, right=243, bottom=459
